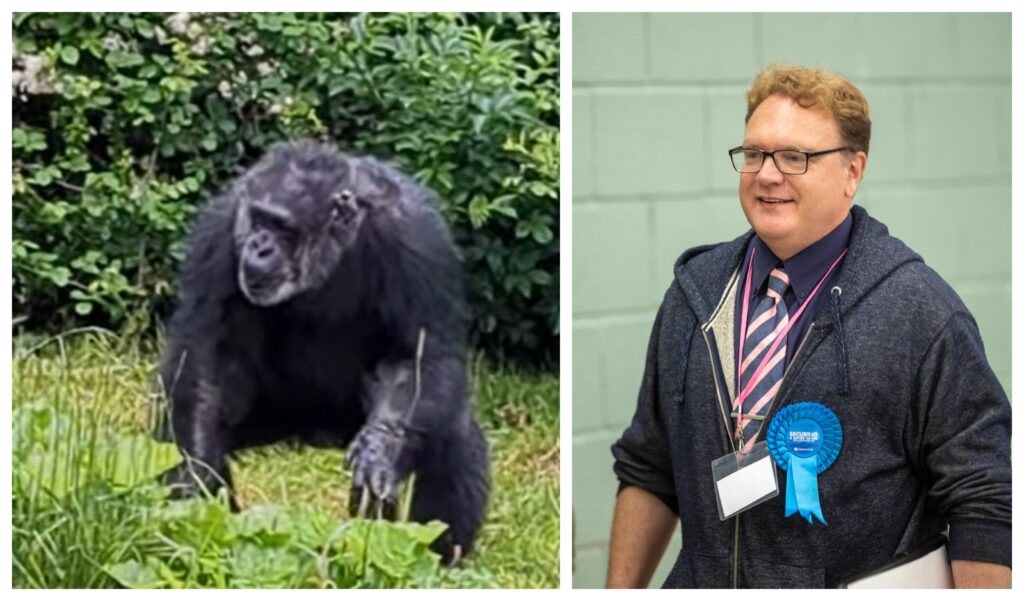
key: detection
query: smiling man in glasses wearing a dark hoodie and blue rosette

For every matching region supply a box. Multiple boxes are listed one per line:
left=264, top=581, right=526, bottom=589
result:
left=607, top=68, right=1011, bottom=588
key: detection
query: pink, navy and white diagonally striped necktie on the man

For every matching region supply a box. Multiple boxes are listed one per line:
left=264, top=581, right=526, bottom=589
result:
left=736, top=267, right=790, bottom=450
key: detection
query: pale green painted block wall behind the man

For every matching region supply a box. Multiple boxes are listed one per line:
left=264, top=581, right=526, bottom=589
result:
left=572, top=13, right=1011, bottom=587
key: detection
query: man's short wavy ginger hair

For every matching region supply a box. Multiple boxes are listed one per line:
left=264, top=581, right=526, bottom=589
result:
left=745, top=65, right=871, bottom=154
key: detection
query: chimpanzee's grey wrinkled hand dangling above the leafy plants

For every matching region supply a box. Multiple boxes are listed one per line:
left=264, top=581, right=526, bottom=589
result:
left=345, top=422, right=406, bottom=519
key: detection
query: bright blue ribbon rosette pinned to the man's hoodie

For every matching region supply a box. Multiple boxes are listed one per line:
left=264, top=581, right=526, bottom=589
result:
left=766, top=402, right=843, bottom=525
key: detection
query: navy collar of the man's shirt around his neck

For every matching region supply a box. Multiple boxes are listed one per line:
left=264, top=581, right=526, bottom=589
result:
left=751, top=213, right=853, bottom=302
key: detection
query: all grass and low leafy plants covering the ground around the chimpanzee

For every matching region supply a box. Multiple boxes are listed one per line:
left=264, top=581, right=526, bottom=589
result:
left=12, top=333, right=559, bottom=588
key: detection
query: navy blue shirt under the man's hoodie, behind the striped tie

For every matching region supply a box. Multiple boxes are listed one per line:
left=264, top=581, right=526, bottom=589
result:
left=734, top=214, right=853, bottom=394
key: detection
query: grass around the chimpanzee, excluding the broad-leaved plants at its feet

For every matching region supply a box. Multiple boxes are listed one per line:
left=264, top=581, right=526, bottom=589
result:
left=12, top=332, right=559, bottom=588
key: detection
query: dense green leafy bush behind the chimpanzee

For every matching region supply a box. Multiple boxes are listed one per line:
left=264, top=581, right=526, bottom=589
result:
left=12, top=13, right=559, bottom=364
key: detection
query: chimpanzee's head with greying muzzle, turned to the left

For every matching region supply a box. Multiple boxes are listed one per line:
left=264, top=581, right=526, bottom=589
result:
left=234, top=158, right=368, bottom=307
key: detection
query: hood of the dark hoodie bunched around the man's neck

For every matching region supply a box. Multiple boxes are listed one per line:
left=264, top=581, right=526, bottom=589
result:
left=675, top=205, right=923, bottom=324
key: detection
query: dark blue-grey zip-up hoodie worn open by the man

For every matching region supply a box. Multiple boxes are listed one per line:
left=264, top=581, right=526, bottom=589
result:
left=612, top=206, right=1011, bottom=588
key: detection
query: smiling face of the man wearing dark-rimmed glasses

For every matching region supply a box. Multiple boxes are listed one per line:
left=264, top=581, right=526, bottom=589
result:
left=739, top=94, right=867, bottom=260
